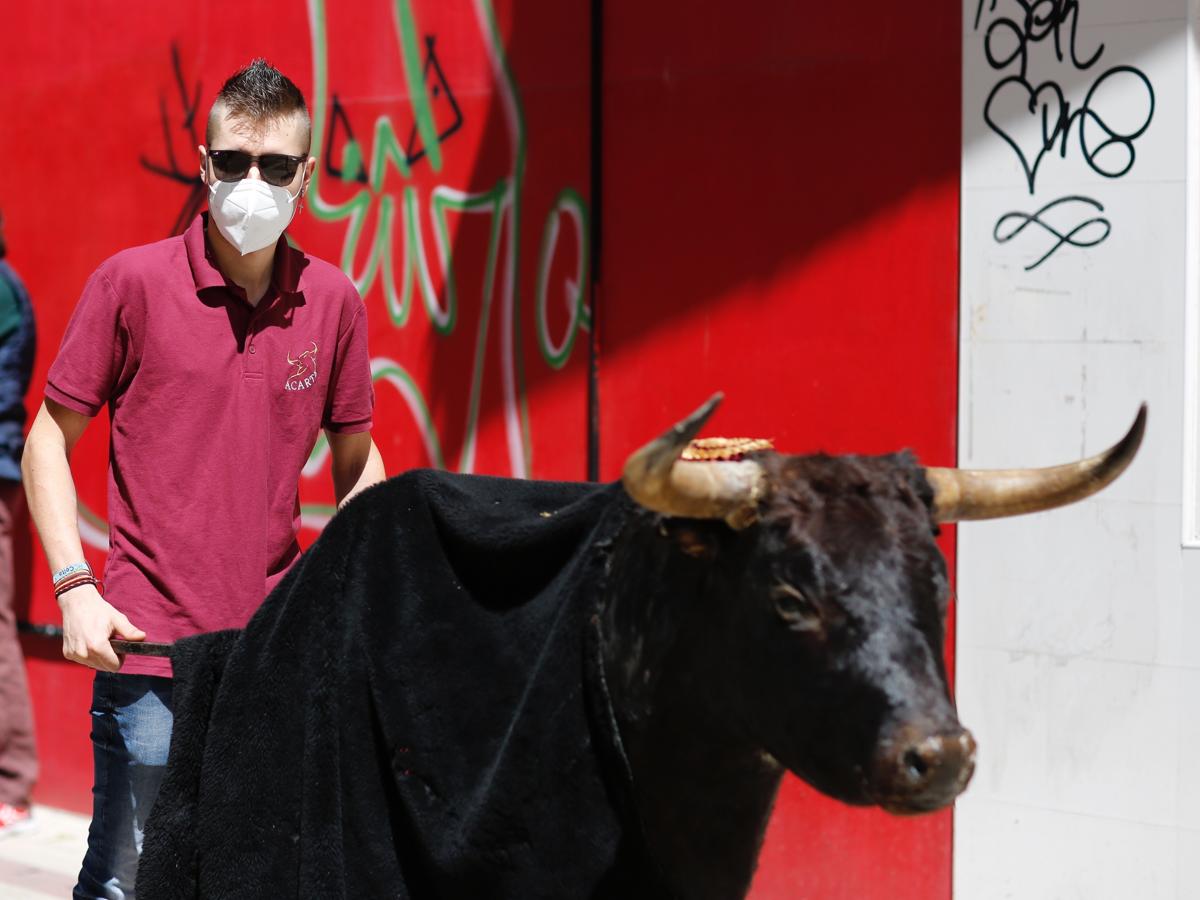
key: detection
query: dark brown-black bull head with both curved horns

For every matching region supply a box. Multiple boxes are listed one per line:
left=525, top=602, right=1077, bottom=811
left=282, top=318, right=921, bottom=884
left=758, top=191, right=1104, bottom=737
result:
left=610, top=395, right=1146, bottom=812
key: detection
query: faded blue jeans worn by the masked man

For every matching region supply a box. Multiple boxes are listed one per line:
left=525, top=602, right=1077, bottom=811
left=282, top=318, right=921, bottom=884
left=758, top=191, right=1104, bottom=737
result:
left=72, top=672, right=174, bottom=900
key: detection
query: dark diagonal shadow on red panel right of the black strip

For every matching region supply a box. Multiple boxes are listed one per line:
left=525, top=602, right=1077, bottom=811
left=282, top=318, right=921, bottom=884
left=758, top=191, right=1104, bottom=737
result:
left=601, top=1, right=959, bottom=374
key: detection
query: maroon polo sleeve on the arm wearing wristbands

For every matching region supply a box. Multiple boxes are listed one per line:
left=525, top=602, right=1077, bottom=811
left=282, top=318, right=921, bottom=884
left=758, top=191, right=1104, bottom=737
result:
left=46, top=266, right=130, bottom=416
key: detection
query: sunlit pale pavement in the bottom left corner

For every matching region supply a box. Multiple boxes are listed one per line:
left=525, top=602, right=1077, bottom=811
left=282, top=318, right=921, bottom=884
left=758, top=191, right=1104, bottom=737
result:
left=0, top=806, right=88, bottom=900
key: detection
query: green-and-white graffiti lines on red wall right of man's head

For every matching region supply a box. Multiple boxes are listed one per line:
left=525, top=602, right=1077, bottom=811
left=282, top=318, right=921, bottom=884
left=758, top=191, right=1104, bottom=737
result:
left=310, top=0, right=590, bottom=475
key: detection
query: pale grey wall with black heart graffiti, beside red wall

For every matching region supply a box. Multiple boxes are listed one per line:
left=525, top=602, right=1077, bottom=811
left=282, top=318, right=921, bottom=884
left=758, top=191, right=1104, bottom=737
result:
left=954, top=0, right=1200, bottom=900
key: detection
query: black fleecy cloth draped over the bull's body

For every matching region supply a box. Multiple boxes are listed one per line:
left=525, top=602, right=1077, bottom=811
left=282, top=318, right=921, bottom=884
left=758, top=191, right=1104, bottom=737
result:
left=138, top=470, right=666, bottom=900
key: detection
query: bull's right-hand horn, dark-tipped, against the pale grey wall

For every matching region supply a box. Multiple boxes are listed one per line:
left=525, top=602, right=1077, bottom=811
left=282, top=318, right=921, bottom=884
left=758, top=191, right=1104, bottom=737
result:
left=925, top=403, right=1146, bottom=522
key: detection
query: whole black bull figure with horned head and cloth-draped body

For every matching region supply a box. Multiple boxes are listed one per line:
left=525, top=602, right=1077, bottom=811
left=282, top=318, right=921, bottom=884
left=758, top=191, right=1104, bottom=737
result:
left=129, top=398, right=1145, bottom=900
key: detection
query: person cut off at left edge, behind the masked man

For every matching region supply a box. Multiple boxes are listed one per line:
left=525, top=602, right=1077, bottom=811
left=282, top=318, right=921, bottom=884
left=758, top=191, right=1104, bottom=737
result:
left=0, top=210, right=37, bottom=838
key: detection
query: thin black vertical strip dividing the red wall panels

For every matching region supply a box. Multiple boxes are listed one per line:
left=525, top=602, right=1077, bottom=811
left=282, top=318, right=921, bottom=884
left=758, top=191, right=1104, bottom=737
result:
left=588, top=0, right=604, bottom=481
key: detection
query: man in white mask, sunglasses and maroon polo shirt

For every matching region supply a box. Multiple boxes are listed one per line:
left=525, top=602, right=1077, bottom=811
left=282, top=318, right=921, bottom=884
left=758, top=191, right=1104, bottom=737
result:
left=24, top=60, right=384, bottom=898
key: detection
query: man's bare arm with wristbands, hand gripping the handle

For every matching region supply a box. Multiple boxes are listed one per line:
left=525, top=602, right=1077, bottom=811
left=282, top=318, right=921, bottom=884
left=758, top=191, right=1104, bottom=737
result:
left=20, top=400, right=145, bottom=672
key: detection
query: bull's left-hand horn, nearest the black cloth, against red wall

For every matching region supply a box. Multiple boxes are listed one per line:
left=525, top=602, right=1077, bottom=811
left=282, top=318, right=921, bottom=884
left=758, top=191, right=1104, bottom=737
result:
left=622, top=392, right=766, bottom=528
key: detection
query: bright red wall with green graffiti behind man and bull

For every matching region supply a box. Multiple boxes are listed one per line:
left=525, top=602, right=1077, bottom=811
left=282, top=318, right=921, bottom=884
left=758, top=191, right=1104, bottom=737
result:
left=0, top=0, right=960, bottom=900
